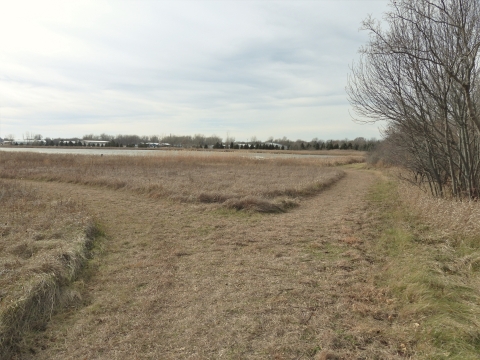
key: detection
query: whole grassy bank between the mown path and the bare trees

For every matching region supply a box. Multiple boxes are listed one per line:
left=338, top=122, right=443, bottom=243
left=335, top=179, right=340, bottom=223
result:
left=370, top=174, right=480, bottom=359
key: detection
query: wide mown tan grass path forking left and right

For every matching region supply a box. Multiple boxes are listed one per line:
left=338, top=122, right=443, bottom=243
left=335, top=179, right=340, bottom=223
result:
left=16, top=170, right=402, bottom=359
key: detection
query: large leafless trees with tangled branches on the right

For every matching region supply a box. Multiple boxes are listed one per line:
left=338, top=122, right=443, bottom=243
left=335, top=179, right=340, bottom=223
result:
left=347, top=0, right=480, bottom=198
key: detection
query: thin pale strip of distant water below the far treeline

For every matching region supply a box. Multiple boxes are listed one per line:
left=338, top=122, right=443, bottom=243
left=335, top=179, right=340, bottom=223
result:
left=0, top=146, right=338, bottom=159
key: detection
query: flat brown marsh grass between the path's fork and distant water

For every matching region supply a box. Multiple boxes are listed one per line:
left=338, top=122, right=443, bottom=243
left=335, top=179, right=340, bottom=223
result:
left=0, top=153, right=356, bottom=212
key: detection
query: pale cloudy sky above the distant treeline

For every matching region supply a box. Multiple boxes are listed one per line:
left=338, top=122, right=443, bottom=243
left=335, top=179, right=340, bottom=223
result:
left=0, top=0, right=388, bottom=140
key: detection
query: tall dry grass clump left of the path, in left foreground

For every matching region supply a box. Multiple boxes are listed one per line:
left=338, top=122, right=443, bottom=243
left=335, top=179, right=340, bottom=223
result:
left=0, top=180, right=96, bottom=359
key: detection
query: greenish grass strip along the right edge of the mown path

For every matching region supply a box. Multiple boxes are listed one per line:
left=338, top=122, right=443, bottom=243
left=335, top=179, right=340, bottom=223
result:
left=369, top=179, right=480, bottom=359
